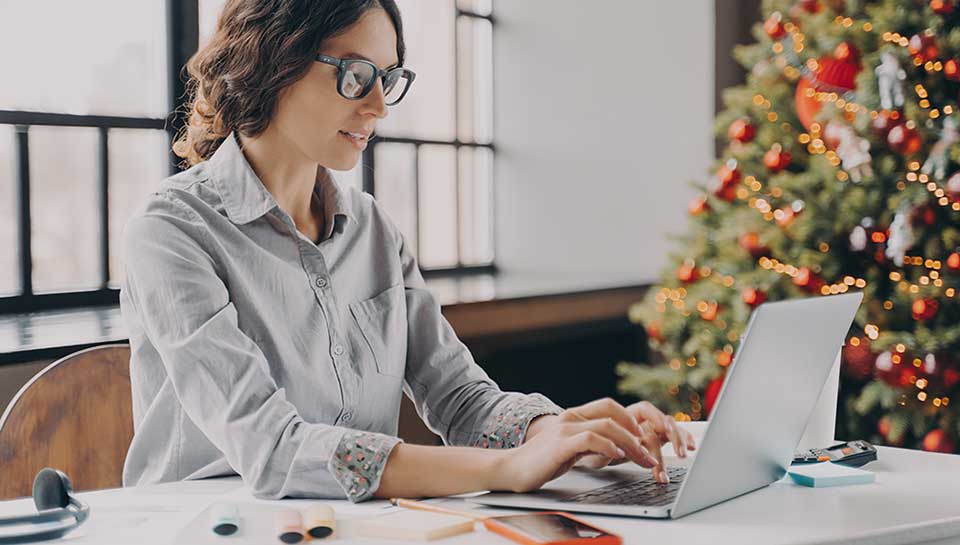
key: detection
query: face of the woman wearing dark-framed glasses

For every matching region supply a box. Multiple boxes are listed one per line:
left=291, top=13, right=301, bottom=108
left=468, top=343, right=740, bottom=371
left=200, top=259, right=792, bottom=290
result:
left=271, top=8, right=398, bottom=170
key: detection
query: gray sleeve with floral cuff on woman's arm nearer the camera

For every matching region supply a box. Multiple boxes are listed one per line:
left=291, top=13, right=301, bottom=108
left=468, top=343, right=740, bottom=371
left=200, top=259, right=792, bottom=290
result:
left=124, top=196, right=400, bottom=501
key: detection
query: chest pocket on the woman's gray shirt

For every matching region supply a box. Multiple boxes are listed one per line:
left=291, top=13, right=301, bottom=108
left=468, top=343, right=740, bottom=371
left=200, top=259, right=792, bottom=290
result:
left=350, top=284, right=407, bottom=378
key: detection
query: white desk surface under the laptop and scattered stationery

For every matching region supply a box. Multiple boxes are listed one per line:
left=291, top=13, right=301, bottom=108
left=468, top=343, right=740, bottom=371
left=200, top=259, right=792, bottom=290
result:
left=0, top=424, right=960, bottom=545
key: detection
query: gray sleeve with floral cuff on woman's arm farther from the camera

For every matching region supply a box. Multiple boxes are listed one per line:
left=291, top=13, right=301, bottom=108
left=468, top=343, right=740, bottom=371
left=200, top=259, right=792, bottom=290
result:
left=395, top=223, right=562, bottom=448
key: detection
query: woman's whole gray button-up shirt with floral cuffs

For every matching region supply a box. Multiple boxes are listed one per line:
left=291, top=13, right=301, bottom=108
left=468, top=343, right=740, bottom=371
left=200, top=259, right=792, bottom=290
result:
left=120, top=135, right=560, bottom=501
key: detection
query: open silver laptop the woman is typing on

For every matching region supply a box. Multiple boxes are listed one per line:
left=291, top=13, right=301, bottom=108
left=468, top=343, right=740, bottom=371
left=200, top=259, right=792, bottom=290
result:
left=467, top=293, right=863, bottom=518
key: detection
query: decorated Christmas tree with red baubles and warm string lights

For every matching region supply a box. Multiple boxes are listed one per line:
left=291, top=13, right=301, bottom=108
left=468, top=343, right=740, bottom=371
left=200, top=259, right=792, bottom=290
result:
left=618, top=0, right=960, bottom=452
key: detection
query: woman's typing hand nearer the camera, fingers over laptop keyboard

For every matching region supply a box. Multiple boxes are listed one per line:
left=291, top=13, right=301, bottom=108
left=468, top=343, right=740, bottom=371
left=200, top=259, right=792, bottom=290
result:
left=494, top=401, right=658, bottom=492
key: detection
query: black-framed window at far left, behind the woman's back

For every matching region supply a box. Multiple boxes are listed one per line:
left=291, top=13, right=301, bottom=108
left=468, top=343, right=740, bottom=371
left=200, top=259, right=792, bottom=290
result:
left=0, top=0, right=179, bottom=313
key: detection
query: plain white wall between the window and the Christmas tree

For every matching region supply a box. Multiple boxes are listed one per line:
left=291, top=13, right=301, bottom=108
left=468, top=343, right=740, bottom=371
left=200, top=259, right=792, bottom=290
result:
left=494, top=0, right=714, bottom=281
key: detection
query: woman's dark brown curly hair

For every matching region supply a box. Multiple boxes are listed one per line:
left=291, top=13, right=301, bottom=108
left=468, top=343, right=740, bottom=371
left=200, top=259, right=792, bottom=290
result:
left=173, top=0, right=405, bottom=167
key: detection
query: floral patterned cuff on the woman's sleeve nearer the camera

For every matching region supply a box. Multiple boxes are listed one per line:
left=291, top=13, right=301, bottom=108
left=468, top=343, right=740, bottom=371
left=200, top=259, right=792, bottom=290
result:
left=328, top=430, right=403, bottom=502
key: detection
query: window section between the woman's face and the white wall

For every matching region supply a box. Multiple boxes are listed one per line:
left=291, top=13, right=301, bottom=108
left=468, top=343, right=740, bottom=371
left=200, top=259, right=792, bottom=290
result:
left=363, top=0, right=494, bottom=272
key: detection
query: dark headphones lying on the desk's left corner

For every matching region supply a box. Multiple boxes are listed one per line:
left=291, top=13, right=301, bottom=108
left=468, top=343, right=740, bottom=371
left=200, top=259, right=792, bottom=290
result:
left=0, top=467, right=90, bottom=545
